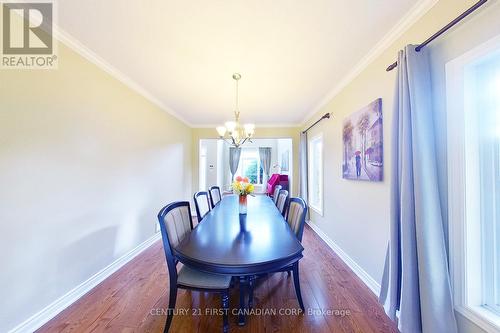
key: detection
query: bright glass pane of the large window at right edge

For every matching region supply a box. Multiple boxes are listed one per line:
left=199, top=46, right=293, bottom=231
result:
left=478, top=53, right=500, bottom=315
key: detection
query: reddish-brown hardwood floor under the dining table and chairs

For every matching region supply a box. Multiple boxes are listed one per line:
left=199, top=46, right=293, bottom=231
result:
left=37, top=225, right=397, bottom=333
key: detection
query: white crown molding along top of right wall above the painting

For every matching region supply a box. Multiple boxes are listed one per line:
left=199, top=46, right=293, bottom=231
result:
left=301, top=0, right=439, bottom=127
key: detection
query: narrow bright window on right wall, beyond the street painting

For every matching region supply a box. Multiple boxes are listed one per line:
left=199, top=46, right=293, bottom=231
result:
left=308, top=134, right=323, bottom=215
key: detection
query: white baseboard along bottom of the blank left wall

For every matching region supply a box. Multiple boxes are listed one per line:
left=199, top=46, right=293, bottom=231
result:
left=9, top=233, right=161, bottom=333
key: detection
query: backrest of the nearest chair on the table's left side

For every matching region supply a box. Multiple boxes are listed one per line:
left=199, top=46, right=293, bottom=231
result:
left=158, top=201, right=193, bottom=282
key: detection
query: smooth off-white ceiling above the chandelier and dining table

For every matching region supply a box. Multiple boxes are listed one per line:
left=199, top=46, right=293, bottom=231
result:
left=58, top=0, right=418, bottom=126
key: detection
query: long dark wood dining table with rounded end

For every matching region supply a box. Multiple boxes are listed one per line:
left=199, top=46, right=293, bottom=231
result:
left=174, top=195, right=304, bottom=325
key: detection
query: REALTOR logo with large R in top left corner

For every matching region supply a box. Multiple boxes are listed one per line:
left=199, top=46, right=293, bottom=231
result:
left=1, top=2, right=57, bottom=69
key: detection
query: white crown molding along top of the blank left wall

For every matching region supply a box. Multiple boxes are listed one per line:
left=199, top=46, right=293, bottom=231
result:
left=53, top=24, right=193, bottom=127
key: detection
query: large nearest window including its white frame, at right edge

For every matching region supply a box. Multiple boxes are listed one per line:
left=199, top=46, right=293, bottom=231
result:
left=446, top=38, right=500, bottom=331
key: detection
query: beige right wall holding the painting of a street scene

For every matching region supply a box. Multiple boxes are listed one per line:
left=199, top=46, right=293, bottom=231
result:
left=304, top=0, right=500, bottom=332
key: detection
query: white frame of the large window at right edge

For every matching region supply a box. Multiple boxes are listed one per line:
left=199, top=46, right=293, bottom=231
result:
left=446, top=36, right=500, bottom=333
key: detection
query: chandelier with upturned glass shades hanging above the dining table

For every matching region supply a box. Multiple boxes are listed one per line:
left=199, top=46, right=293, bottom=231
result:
left=216, top=73, right=255, bottom=148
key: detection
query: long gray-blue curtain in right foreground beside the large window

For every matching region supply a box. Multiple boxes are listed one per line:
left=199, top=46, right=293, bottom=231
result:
left=380, top=45, right=457, bottom=333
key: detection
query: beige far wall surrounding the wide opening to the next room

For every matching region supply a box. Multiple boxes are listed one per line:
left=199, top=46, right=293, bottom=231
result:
left=192, top=126, right=300, bottom=196
